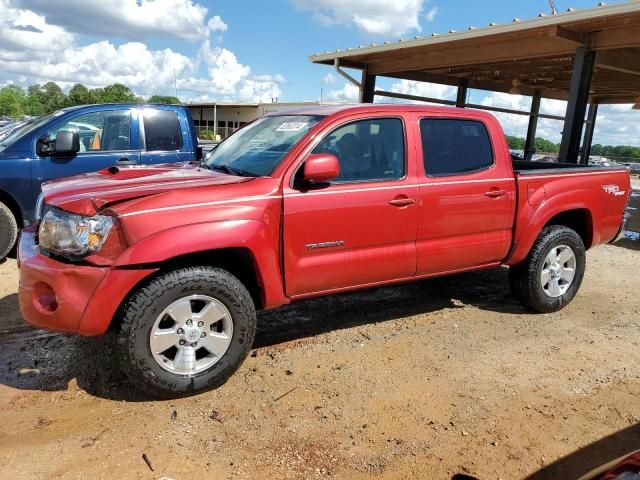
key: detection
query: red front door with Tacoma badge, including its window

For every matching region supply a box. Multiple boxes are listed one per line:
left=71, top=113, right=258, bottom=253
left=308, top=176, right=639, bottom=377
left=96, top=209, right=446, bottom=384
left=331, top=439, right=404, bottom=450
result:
left=283, top=117, right=418, bottom=296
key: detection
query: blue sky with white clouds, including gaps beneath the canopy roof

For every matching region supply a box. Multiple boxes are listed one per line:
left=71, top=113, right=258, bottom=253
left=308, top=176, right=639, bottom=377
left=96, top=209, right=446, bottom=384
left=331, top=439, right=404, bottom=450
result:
left=0, top=0, right=640, bottom=144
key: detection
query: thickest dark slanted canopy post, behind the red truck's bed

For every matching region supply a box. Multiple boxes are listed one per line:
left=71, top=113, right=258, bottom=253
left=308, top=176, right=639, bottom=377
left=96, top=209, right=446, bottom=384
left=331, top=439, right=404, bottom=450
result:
left=559, top=46, right=596, bottom=163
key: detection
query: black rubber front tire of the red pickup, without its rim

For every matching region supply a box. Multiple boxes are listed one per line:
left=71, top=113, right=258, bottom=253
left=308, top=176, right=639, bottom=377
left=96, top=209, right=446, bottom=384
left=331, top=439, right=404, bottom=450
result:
left=116, top=266, right=256, bottom=398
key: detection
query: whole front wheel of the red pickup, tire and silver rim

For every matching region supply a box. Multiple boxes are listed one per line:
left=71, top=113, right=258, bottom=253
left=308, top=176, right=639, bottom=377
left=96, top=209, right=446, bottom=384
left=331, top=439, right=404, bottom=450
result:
left=117, top=266, right=256, bottom=398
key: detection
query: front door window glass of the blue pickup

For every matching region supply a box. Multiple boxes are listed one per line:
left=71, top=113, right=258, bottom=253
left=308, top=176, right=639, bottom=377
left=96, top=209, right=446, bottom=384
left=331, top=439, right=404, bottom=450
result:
left=49, top=110, right=131, bottom=152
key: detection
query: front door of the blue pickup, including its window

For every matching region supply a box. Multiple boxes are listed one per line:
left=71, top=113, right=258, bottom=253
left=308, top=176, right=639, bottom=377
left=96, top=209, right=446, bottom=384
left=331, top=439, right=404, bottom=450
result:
left=33, top=108, right=140, bottom=198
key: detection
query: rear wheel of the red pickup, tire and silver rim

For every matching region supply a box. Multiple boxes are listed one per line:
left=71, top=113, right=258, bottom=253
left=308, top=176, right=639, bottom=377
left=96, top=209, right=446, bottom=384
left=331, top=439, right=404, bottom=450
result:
left=509, top=225, right=586, bottom=313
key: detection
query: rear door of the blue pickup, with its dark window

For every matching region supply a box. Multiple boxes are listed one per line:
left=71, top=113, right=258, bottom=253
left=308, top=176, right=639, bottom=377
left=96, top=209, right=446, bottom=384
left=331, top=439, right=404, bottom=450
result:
left=140, top=106, right=196, bottom=164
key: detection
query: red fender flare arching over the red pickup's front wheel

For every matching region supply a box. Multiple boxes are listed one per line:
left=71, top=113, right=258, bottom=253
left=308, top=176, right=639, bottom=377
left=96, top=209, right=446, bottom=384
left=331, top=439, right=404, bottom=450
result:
left=112, top=220, right=289, bottom=309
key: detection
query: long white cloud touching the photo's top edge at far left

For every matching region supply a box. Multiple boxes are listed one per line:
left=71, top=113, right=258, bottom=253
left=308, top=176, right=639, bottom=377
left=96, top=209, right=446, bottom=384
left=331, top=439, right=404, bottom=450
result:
left=14, top=0, right=222, bottom=41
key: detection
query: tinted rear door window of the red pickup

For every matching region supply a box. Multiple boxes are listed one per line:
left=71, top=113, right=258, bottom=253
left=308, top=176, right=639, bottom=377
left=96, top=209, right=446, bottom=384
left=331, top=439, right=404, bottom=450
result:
left=420, top=118, right=493, bottom=176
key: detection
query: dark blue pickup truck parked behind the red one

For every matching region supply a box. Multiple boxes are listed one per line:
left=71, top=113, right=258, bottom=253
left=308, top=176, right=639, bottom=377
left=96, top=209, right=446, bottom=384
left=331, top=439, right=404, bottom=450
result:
left=0, top=104, right=198, bottom=261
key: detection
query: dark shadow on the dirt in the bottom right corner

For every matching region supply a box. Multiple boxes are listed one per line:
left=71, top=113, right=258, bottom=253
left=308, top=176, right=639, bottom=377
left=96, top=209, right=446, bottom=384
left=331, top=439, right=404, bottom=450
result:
left=527, top=424, right=640, bottom=480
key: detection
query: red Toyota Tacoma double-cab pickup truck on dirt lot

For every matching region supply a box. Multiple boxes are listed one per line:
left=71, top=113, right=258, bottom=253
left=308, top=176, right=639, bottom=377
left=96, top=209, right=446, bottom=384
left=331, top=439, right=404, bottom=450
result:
left=19, top=105, right=630, bottom=396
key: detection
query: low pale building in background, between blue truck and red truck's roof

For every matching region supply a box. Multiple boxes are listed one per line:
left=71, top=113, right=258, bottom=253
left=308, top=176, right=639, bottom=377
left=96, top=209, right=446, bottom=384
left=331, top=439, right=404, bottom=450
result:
left=187, top=102, right=342, bottom=140
